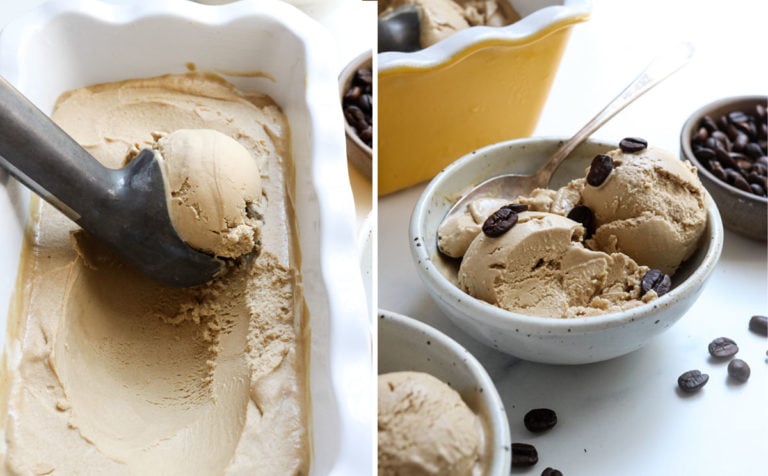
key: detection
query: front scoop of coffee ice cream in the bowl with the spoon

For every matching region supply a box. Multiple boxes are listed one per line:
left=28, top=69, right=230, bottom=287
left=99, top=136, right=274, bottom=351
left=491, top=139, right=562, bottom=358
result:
left=458, top=212, right=656, bottom=317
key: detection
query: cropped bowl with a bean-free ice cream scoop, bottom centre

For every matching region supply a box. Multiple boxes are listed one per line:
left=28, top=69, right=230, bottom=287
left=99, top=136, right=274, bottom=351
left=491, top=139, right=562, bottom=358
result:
left=378, top=310, right=511, bottom=476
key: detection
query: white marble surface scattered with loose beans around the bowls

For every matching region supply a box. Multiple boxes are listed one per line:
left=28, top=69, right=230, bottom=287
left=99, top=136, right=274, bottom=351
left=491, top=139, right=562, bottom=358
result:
left=378, top=0, right=768, bottom=476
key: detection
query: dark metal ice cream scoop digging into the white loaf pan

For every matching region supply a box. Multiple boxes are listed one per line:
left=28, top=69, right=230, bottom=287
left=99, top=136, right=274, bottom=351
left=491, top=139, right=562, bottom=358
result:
left=0, top=77, right=224, bottom=286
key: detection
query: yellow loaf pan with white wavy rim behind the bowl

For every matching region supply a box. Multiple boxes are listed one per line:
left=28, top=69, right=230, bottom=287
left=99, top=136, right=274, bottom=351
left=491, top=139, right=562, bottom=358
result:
left=377, top=0, right=592, bottom=195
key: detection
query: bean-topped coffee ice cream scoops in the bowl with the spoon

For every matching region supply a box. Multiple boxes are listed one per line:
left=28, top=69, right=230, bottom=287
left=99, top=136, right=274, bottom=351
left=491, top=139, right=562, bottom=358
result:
left=438, top=139, right=706, bottom=317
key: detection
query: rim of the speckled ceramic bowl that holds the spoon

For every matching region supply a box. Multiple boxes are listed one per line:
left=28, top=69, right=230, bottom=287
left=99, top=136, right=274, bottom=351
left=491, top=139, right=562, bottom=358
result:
left=409, top=137, right=723, bottom=336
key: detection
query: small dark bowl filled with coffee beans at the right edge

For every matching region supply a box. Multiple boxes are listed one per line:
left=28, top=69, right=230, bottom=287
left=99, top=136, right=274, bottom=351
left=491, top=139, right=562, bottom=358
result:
left=680, top=96, right=768, bottom=241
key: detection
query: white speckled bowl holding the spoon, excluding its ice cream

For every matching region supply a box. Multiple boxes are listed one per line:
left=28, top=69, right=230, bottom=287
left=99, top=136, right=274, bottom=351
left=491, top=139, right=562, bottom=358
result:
left=410, top=138, right=723, bottom=364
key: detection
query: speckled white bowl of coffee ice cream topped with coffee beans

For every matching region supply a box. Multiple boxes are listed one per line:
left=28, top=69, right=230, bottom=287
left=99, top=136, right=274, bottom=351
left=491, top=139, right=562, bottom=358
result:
left=410, top=138, right=723, bottom=364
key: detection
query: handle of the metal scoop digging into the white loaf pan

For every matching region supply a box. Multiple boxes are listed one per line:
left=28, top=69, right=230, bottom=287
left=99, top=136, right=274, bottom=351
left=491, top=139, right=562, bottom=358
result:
left=0, top=77, right=115, bottom=222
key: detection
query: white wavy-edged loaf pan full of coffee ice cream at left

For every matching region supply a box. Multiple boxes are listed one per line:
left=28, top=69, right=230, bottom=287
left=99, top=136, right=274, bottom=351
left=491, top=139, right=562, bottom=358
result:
left=0, top=0, right=373, bottom=474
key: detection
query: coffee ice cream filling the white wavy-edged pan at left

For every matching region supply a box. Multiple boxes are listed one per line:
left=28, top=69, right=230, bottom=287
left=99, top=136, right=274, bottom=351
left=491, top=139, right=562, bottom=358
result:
left=0, top=73, right=309, bottom=475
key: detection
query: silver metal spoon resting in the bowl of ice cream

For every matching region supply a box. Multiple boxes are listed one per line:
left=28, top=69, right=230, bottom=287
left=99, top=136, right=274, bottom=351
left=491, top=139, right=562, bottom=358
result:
left=444, top=42, right=693, bottom=221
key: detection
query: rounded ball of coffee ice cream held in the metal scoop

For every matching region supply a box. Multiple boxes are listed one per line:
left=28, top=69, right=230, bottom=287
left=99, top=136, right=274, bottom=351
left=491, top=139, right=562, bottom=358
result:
left=157, top=129, right=261, bottom=258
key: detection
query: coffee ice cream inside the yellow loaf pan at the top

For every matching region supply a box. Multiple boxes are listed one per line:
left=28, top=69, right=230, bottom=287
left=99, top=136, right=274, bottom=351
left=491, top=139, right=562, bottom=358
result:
left=379, top=0, right=517, bottom=48
